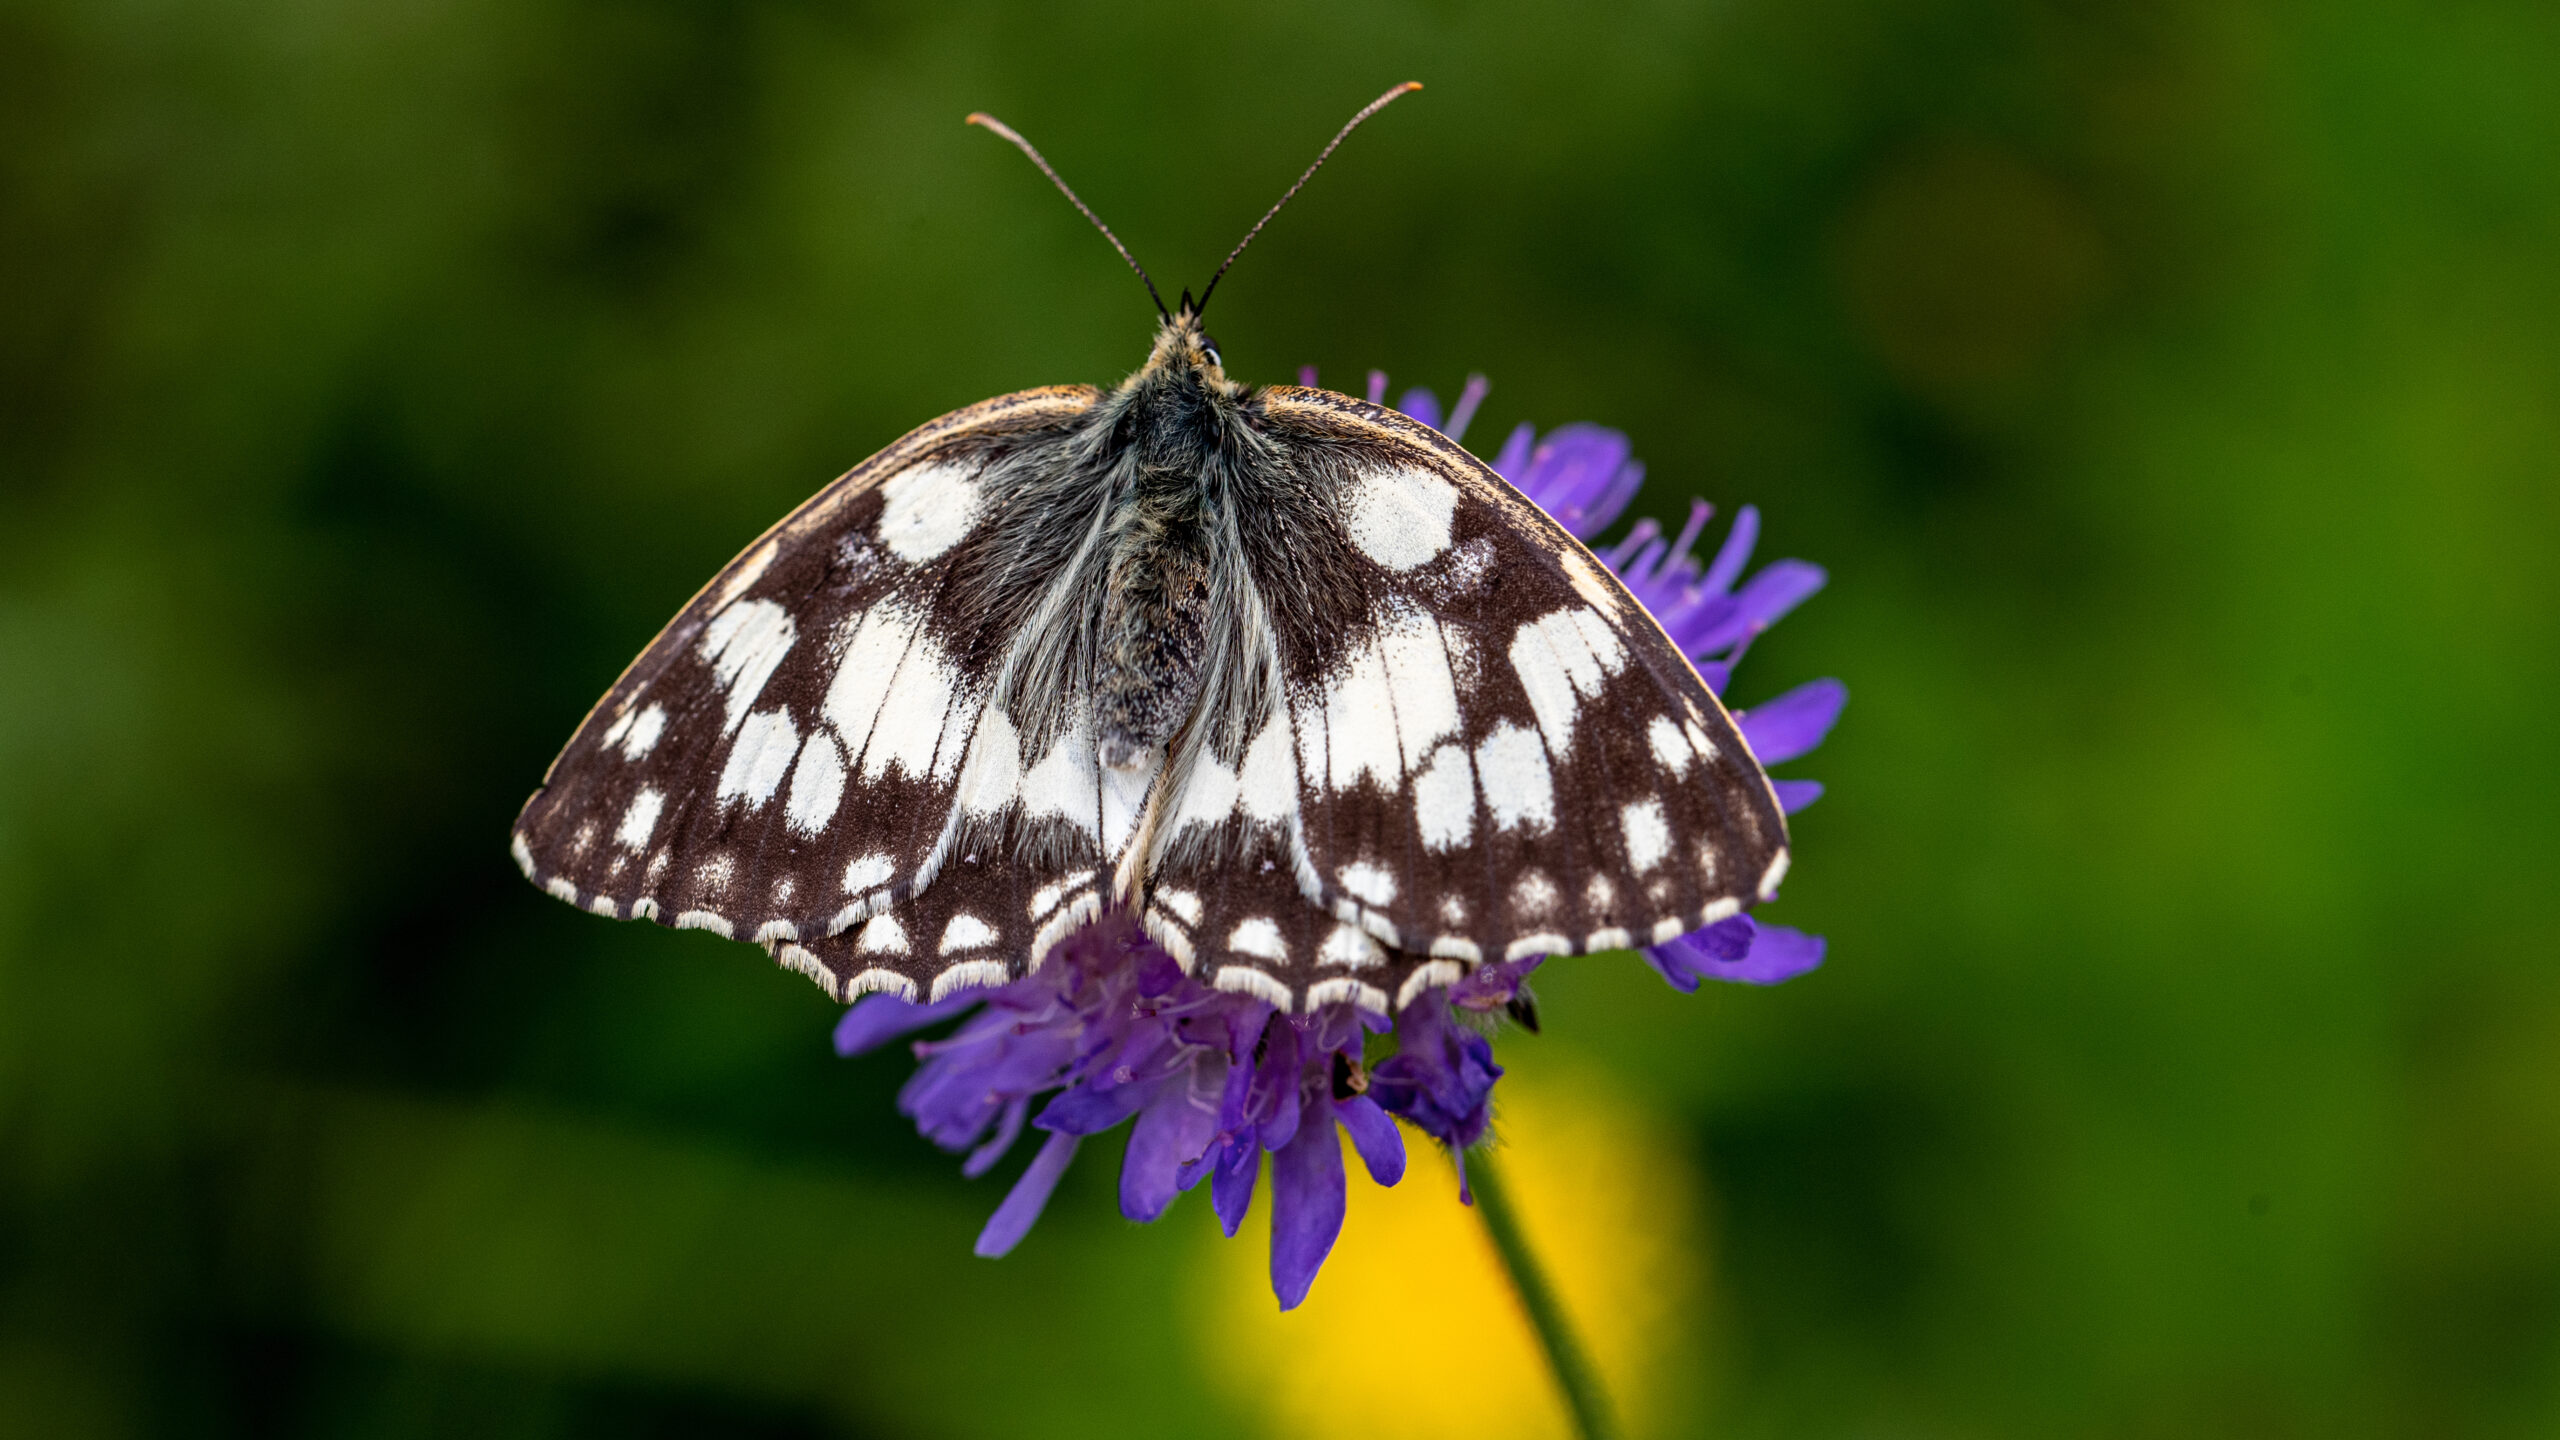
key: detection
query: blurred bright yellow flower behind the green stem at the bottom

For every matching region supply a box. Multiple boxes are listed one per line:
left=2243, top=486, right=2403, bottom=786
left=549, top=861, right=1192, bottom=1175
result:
left=1196, top=1043, right=1710, bottom=1440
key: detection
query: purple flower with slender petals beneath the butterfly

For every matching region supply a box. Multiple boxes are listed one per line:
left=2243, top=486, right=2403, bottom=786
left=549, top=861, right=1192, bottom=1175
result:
left=835, top=366, right=1848, bottom=1309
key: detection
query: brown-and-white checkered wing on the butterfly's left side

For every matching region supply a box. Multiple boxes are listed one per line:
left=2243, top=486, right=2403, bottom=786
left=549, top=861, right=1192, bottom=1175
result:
left=512, top=387, right=1131, bottom=994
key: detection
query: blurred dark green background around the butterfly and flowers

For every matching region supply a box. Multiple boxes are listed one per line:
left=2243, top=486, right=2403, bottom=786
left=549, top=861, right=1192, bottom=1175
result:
left=0, top=0, right=2560, bottom=1437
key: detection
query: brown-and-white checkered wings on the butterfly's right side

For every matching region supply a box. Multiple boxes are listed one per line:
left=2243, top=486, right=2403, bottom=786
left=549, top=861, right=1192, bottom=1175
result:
left=1144, top=387, right=1787, bottom=1010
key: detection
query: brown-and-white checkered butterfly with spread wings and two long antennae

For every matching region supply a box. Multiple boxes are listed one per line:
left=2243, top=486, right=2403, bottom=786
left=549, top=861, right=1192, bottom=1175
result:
left=512, top=85, right=1787, bottom=1012
